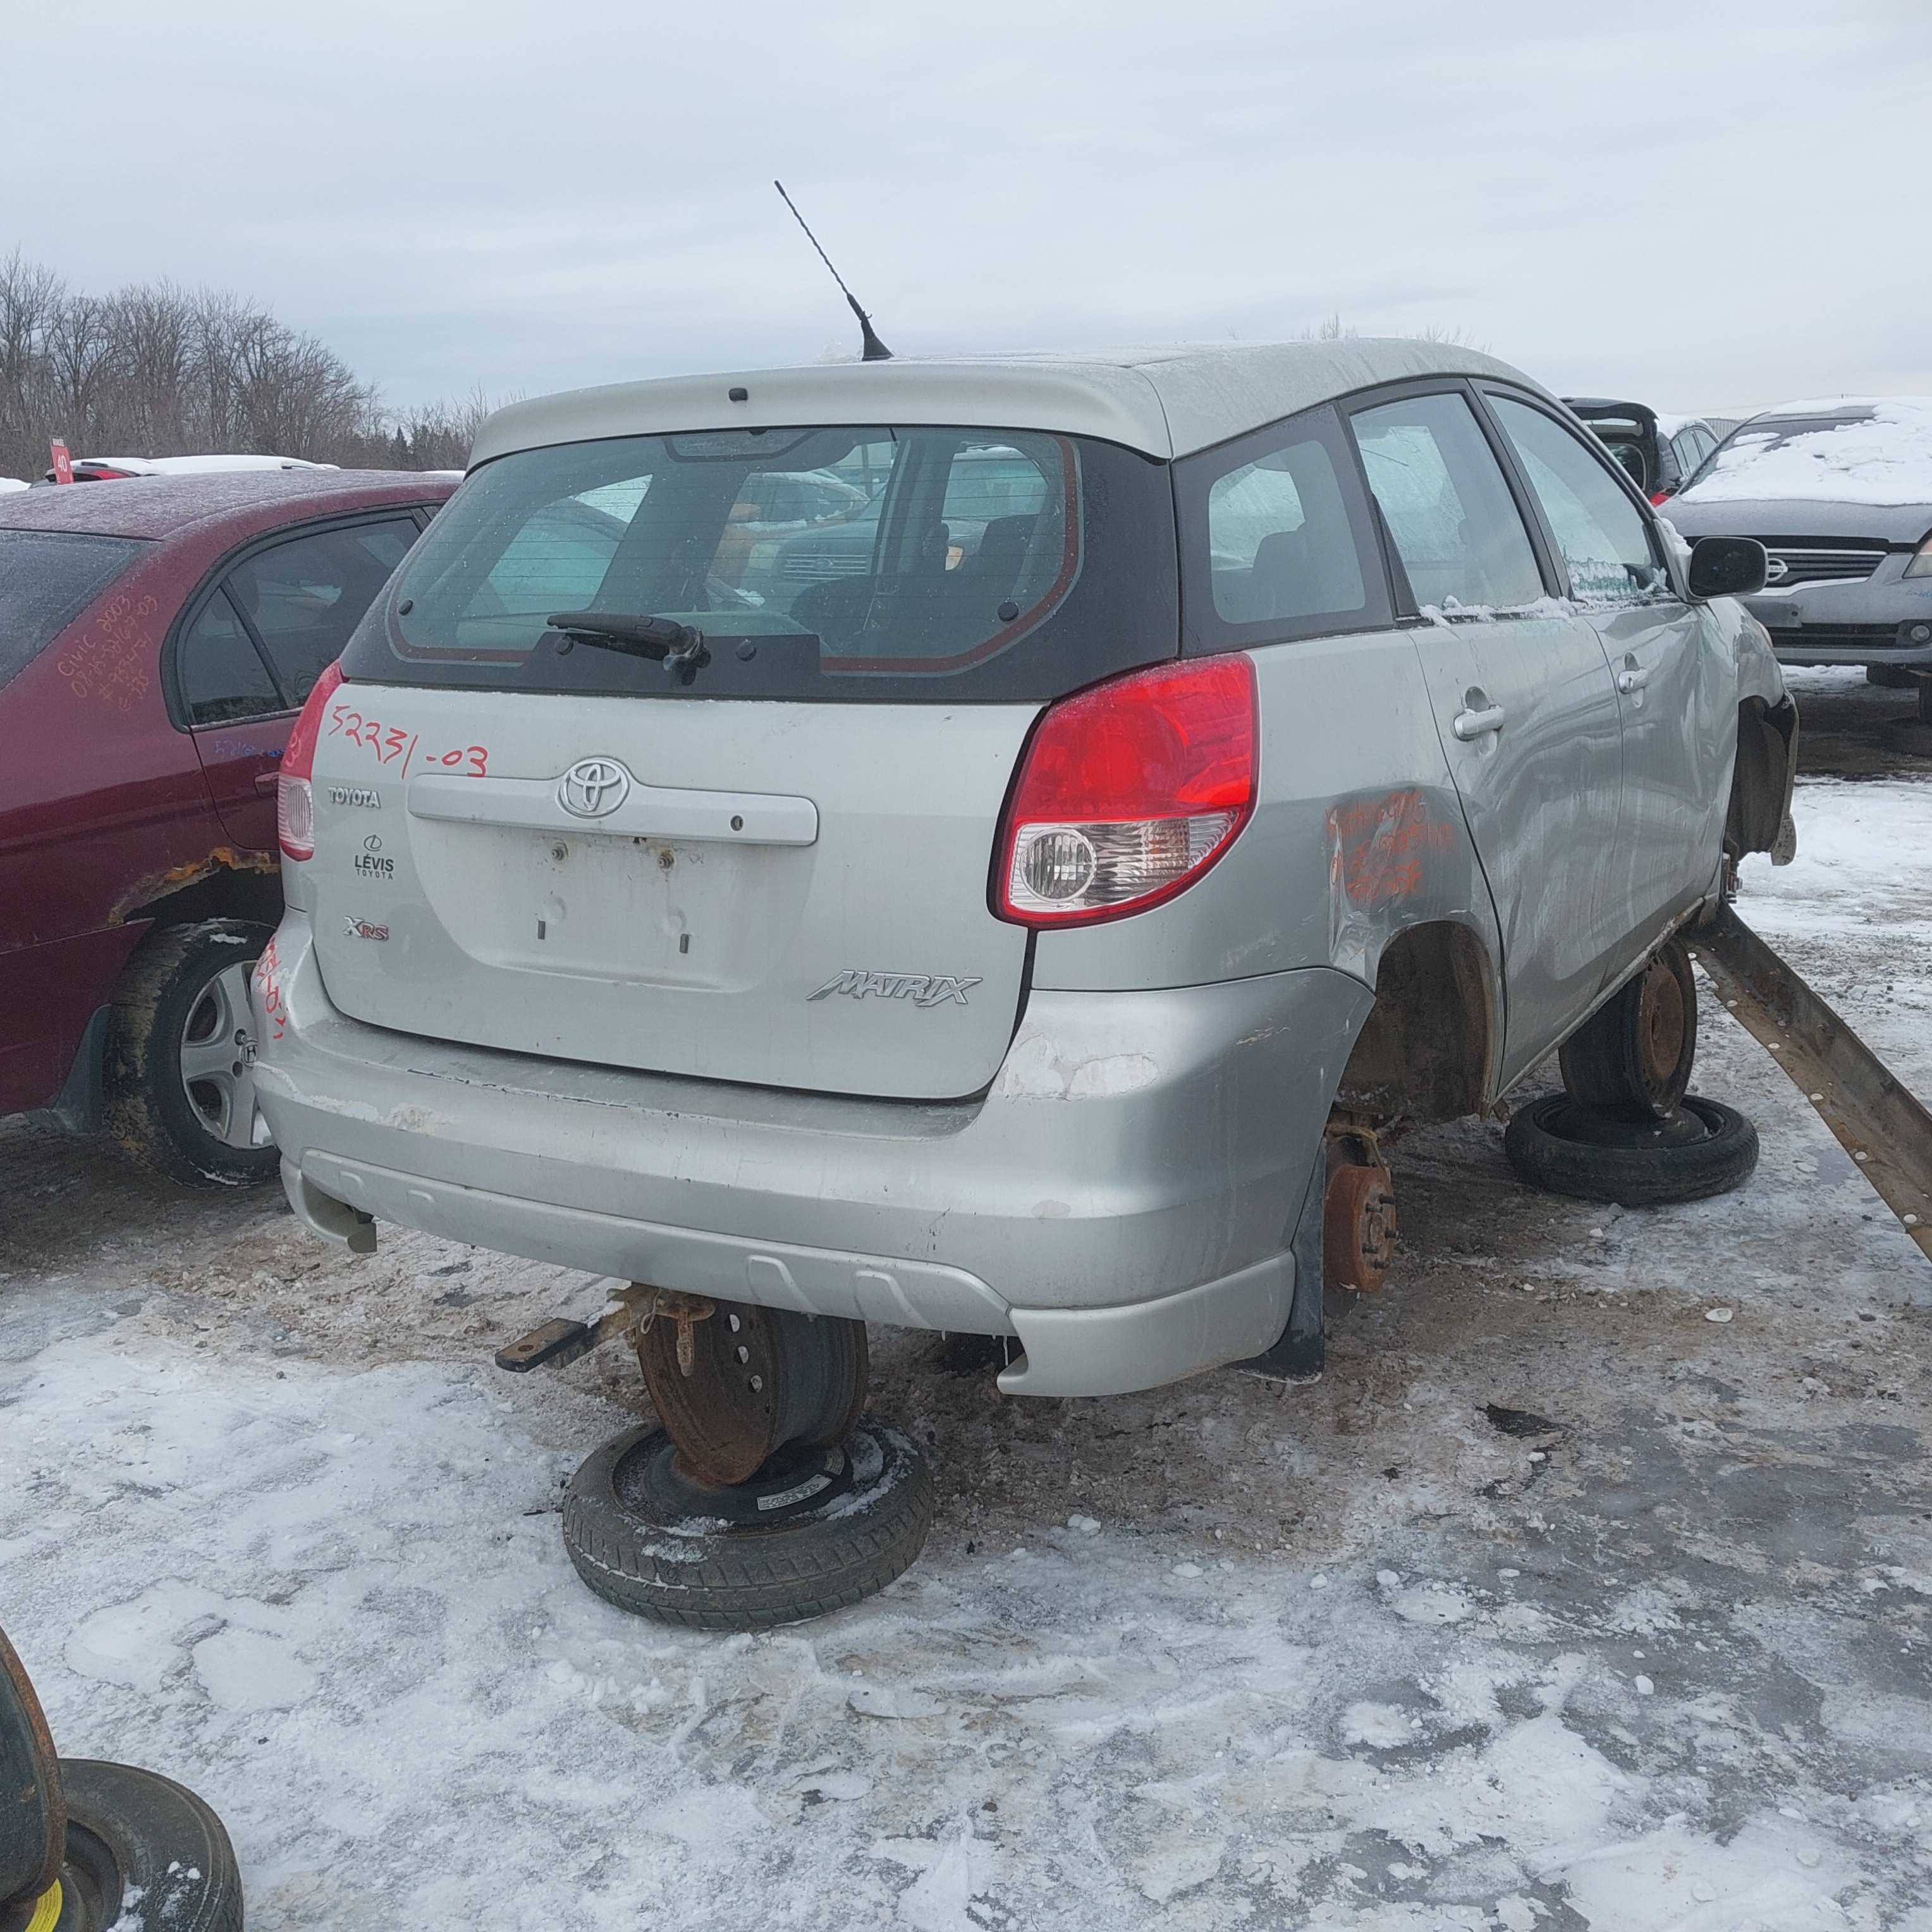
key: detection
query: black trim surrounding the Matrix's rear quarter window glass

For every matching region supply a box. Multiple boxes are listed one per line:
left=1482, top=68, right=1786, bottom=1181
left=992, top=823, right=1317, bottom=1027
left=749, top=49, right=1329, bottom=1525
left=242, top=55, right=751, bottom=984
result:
left=1171, top=400, right=1397, bottom=657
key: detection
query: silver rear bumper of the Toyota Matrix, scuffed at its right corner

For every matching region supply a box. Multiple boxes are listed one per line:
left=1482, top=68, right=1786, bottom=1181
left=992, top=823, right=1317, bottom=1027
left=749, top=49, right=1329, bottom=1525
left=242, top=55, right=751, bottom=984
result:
left=257, top=912, right=1372, bottom=1395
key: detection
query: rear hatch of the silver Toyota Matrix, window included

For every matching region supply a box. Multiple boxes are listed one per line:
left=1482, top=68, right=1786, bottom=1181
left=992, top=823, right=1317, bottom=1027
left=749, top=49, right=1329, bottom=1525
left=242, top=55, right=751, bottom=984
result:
left=309, top=429, right=1178, bottom=1099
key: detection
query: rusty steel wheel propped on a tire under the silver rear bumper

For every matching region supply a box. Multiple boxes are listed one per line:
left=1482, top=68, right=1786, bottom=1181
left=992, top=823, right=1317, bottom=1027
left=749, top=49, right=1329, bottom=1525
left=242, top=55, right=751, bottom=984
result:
left=635, top=1292, right=869, bottom=1488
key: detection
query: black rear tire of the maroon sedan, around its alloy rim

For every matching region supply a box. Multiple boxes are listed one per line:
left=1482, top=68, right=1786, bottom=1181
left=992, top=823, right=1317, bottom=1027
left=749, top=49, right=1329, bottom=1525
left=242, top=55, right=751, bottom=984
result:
left=106, top=920, right=280, bottom=1186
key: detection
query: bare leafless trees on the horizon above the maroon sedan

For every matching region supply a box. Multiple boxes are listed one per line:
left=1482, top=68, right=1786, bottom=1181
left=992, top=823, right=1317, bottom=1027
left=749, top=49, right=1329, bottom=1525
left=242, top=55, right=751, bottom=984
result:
left=0, top=249, right=491, bottom=479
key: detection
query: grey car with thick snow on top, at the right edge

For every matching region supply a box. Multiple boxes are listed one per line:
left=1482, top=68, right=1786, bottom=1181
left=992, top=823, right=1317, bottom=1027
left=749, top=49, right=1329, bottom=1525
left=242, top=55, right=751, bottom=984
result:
left=1669, top=396, right=1932, bottom=723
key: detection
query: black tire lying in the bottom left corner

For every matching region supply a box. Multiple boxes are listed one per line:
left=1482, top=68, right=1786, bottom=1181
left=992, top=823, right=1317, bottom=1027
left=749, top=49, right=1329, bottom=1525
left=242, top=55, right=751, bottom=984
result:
left=54, top=1758, right=242, bottom=1932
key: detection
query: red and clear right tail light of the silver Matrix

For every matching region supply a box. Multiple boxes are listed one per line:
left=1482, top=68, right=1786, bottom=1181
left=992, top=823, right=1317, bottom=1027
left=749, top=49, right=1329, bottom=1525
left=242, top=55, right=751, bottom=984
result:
left=995, top=655, right=1256, bottom=927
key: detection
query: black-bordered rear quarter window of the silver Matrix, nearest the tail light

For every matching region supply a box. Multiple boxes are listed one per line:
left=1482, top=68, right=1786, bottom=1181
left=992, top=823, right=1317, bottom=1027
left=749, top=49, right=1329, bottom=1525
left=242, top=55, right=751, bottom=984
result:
left=1175, top=410, right=1389, bottom=649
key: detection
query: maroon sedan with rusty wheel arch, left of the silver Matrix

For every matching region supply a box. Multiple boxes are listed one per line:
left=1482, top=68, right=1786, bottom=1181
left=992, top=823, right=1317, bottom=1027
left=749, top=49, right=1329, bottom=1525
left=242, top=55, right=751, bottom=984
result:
left=0, top=470, right=454, bottom=1182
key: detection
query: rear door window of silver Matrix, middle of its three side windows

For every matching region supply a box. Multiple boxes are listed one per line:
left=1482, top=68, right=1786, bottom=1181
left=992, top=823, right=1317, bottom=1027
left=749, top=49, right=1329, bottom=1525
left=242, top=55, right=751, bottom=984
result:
left=1350, top=394, right=1544, bottom=616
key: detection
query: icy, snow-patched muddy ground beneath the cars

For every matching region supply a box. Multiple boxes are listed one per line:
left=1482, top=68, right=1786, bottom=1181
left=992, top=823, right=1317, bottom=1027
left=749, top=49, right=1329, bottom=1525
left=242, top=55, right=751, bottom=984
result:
left=0, top=675, right=1932, bottom=1932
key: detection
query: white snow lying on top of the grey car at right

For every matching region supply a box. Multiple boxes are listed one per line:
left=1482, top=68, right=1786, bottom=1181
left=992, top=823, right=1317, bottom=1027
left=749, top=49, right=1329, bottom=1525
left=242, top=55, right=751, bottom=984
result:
left=1677, top=396, right=1932, bottom=504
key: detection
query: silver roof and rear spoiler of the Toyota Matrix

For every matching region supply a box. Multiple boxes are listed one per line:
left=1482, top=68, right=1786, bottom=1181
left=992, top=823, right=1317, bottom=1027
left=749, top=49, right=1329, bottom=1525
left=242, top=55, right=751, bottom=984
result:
left=470, top=336, right=1548, bottom=463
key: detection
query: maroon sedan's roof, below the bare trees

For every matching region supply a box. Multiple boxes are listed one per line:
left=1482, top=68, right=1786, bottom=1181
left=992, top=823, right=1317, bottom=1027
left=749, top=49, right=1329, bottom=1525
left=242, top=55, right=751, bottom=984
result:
left=0, top=470, right=456, bottom=537
